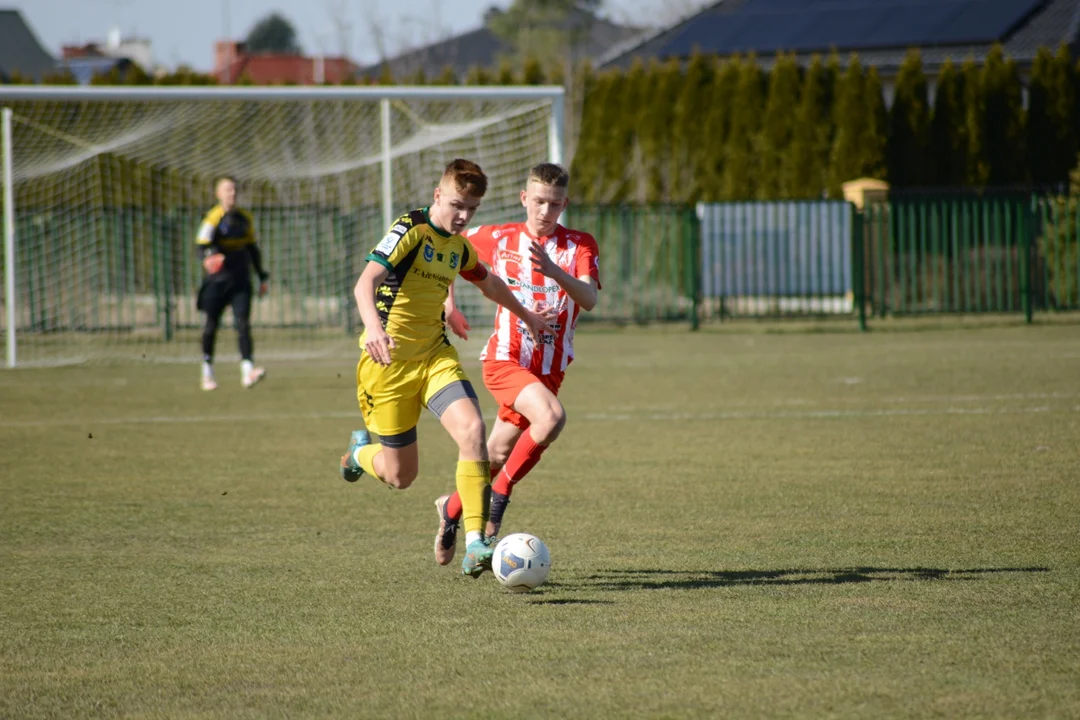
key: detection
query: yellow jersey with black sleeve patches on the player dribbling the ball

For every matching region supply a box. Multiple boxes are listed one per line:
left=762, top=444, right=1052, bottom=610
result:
left=360, top=207, right=486, bottom=362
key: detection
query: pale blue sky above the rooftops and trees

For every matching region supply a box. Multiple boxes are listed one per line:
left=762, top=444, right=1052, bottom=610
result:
left=12, top=0, right=673, bottom=71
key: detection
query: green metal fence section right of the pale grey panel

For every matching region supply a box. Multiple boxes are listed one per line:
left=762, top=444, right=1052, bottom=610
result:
left=861, top=195, right=1080, bottom=321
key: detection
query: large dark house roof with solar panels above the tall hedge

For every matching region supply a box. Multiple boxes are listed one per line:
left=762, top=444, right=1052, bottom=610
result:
left=597, top=0, right=1080, bottom=72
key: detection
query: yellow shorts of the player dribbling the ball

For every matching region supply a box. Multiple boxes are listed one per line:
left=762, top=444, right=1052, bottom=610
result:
left=356, top=344, right=476, bottom=447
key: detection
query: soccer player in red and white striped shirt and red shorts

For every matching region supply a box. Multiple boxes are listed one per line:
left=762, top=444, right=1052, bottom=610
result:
left=435, top=163, right=600, bottom=565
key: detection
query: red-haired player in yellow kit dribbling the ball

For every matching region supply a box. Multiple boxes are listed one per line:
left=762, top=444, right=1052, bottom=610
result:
left=341, top=160, right=548, bottom=578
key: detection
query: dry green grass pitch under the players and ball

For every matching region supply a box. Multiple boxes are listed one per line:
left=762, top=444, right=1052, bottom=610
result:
left=0, top=324, right=1080, bottom=718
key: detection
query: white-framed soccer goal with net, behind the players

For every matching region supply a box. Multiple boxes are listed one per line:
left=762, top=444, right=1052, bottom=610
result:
left=0, top=86, right=563, bottom=365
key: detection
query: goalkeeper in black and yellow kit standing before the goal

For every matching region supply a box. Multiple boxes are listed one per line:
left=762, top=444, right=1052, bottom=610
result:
left=195, top=177, right=270, bottom=390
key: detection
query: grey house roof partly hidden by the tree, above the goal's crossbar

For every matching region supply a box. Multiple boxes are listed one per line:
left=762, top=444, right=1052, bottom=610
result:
left=361, top=15, right=643, bottom=78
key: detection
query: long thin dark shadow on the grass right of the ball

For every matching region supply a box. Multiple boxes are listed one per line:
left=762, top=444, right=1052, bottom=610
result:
left=559, top=567, right=1050, bottom=592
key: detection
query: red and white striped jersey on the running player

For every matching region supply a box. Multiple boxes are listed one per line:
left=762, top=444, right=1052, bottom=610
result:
left=464, top=222, right=600, bottom=375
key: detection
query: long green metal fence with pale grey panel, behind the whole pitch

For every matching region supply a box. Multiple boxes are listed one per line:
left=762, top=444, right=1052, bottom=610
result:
left=4, top=194, right=1080, bottom=354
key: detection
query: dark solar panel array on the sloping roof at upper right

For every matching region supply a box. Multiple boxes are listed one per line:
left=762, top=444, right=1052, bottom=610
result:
left=660, top=0, right=1045, bottom=56
